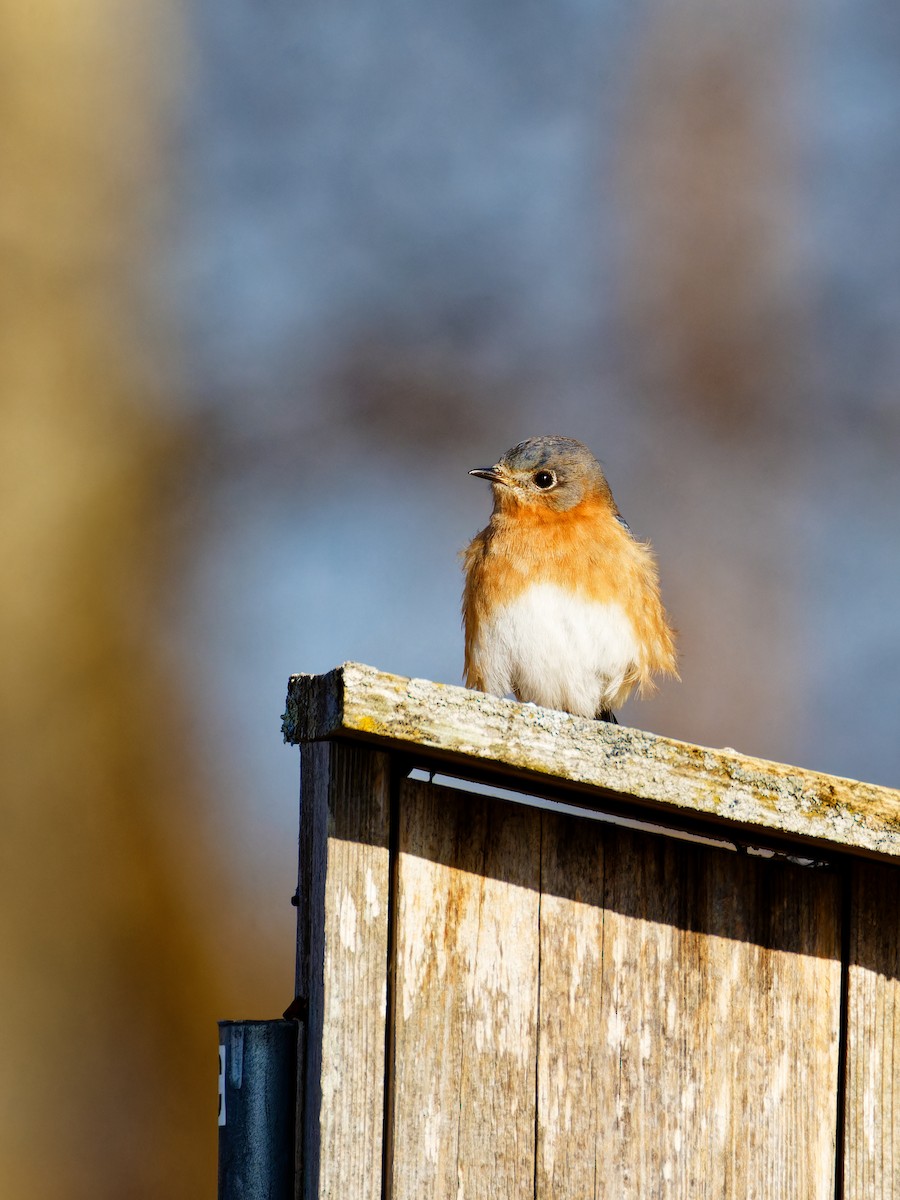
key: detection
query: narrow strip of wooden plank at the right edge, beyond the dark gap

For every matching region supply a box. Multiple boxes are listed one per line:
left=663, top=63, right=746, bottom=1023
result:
left=844, top=862, right=900, bottom=1200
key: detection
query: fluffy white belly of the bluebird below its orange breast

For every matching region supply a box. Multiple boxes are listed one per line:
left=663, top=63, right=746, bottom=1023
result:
left=473, top=583, right=638, bottom=716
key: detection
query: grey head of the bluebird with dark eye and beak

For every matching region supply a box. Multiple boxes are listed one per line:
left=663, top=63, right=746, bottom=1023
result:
left=469, top=437, right=616, bottom=512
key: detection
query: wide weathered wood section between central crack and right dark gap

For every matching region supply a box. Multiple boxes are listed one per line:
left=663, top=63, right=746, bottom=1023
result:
left=536, top=815, right=840, bottom=1200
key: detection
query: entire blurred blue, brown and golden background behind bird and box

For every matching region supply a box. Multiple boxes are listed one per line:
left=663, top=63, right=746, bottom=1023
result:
left=7, top=0, right=900, bottom=1200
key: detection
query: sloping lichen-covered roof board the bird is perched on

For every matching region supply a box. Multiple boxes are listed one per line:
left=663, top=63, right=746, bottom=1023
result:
left=283, top=662, right=900, bottom=859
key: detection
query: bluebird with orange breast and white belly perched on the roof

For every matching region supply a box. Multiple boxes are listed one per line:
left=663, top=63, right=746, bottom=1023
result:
left=462, top=437, right=678, bottom=721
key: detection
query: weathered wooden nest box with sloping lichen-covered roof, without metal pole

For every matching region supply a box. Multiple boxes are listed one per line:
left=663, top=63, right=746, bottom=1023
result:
left=284, top=664, right=900, bottom=1200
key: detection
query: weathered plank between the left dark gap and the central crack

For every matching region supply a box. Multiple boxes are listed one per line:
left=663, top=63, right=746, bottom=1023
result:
left=391, top=781, right=540, bottom=1200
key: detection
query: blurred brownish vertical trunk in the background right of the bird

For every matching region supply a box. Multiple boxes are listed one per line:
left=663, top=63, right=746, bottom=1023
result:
left=616, top=0, right=814, bottom=757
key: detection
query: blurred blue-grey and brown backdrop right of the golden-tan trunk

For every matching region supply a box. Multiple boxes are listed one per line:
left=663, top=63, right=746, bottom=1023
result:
left=176, top=0, right=900, bottom=979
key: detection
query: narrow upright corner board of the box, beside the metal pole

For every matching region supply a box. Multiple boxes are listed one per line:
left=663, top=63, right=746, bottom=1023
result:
left=298, top=743, right=390, bottom=1200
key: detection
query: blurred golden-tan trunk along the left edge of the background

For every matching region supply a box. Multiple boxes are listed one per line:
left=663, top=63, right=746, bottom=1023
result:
left=0, top=0, right=228, bottom=1200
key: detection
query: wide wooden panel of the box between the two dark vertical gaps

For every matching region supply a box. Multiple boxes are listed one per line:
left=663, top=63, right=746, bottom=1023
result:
left=390, top=782, right=841, bottom=1200
